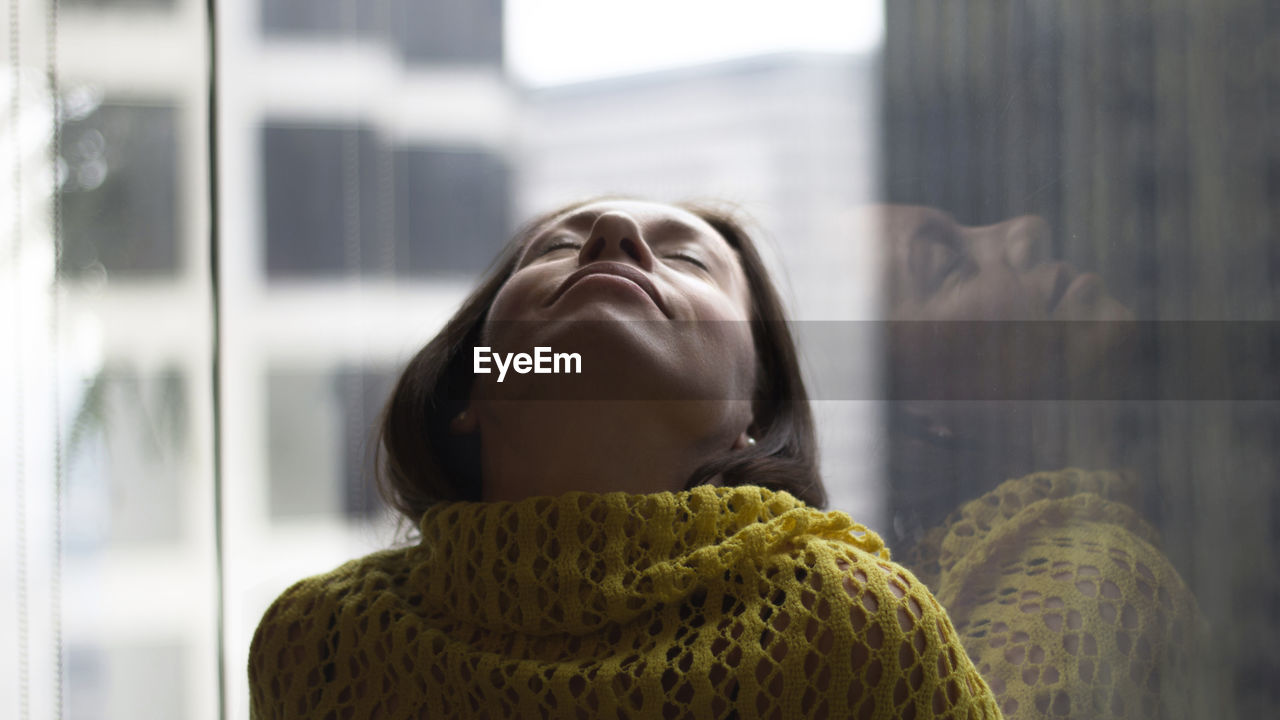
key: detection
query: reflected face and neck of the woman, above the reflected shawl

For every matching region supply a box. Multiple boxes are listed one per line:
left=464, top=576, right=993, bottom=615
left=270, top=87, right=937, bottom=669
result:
left=872, top=206, right=1134, bottom=523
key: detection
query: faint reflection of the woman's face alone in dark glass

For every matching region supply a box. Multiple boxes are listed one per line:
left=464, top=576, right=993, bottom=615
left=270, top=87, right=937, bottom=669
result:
left=877, top=206, right=1133, bottom=400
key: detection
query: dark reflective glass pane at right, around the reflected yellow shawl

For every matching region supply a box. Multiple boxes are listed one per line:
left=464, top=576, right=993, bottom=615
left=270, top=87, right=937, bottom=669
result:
left=883, top=1, right=1280, bottom=716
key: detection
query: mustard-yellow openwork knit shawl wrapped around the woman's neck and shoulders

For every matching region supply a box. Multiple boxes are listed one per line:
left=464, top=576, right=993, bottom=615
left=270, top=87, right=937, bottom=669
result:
left=250, top=487, right=1000, bottom=720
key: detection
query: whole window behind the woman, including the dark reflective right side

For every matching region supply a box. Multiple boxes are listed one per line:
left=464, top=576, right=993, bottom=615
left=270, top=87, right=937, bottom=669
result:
left=0, top=0, right=1280, bottom=720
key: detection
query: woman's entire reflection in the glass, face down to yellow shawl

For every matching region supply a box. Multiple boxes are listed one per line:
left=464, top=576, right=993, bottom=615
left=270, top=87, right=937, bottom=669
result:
left=868, top=206, right=1198, bottom=717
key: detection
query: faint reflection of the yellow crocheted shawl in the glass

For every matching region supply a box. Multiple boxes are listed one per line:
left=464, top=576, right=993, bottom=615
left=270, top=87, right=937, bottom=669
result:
left=919, top=470, right=1199, bottom=719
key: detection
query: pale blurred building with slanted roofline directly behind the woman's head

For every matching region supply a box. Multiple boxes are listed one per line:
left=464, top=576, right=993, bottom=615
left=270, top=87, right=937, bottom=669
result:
left=516, top=53, right=883, bottom=525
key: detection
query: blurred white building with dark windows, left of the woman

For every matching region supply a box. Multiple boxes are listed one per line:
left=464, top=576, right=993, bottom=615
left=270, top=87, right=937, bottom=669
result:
left=58, top=0, right=513, bottom=719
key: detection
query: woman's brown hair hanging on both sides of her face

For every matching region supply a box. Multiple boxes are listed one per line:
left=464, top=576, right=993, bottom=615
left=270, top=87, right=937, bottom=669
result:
left=376, top=199, right=827, bottom=524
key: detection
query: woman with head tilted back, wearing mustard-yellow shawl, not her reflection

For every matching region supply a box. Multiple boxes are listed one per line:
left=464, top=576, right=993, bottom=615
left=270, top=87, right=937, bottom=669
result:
left=250, top=200, right=998, bottom=719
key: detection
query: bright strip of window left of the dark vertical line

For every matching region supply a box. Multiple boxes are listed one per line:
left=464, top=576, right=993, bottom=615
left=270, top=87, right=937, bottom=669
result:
left=0, top=0, right=212, bottom=720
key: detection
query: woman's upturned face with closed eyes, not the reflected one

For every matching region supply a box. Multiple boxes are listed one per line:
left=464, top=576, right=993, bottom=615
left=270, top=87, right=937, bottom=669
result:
left=484, top=200, right=755, bottom=400
